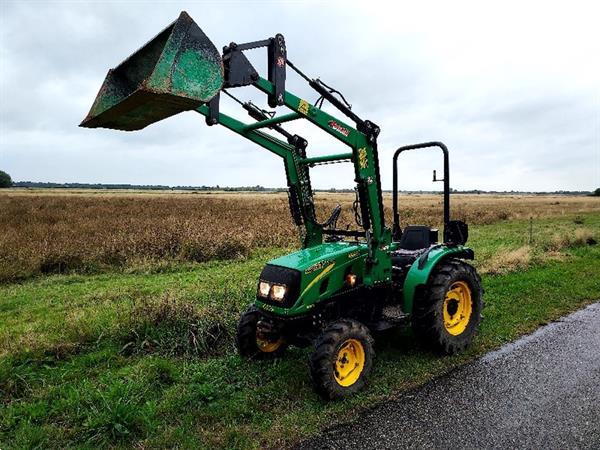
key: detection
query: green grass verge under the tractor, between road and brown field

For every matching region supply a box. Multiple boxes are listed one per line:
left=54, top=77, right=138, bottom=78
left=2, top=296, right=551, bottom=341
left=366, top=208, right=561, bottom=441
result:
left=0, top=214, right=600, bottom=449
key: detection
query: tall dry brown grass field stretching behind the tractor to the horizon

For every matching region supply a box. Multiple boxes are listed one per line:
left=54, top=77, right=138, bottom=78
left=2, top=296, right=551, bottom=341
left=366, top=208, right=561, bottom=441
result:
left=0, top=190, right=600, bottom=281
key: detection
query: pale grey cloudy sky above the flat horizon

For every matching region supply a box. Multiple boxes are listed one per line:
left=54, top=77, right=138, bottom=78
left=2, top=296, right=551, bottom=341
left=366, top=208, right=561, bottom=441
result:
left=0, top=0, right=600, bottom=190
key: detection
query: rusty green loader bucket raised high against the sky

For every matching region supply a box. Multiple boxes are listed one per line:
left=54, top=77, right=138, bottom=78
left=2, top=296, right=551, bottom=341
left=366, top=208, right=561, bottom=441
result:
left=80, top=11, right=223, bottom=131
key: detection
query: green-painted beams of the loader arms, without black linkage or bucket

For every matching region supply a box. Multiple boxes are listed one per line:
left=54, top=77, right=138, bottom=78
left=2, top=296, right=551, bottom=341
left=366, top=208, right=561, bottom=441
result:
left=196, top=74, right=391, bottom=282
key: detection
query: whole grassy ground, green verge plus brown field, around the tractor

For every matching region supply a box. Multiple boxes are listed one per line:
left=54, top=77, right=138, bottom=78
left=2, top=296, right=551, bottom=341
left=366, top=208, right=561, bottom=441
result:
left=0, top=192, right=600, bottom=449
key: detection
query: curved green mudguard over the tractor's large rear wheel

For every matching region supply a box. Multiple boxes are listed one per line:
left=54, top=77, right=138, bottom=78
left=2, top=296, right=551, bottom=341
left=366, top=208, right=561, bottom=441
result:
left=402, top=245, right=475, bottom=314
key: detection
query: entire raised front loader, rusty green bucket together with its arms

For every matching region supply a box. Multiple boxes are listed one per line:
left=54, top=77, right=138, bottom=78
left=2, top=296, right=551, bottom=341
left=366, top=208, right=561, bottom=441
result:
left=81, top=11, right=392, bottom=285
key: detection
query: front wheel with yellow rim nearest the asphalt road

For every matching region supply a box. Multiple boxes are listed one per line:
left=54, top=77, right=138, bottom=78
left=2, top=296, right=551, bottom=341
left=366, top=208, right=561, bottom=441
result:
left=310, top=319, right=375, bottom=400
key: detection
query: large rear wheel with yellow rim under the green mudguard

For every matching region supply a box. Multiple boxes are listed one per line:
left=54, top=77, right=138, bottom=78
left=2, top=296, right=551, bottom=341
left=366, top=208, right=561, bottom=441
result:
left=412, top=259, right=483, bottom=355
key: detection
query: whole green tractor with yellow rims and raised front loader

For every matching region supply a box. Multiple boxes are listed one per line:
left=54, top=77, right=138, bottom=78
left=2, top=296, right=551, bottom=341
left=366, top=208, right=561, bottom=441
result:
left=81, top=12, right=482, bottom=399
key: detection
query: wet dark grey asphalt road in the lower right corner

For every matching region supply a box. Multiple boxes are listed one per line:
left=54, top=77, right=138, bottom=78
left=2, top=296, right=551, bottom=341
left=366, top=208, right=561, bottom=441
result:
left=298, top=303, right=600, bottom=449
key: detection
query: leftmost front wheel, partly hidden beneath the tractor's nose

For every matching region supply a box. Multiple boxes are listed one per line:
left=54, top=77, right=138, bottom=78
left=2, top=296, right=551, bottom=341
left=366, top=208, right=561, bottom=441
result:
left=235, top=307, right=287, bottom=359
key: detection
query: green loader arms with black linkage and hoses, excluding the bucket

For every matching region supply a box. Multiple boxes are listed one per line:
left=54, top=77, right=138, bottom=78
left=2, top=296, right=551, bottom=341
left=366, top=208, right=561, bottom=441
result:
left=196, top=34, right=392, bottom=286
